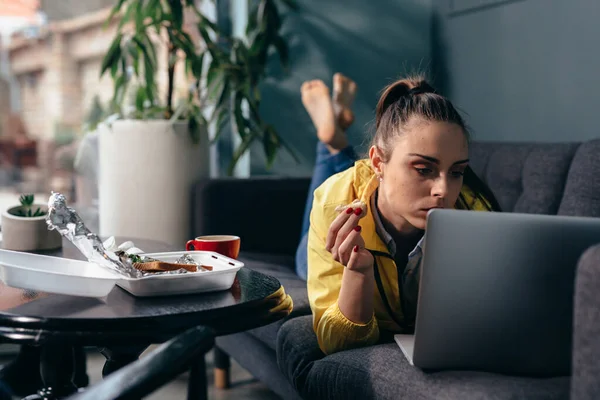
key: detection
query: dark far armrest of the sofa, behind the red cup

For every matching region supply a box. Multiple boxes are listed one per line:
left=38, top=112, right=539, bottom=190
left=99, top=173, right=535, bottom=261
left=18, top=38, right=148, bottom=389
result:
left=190, top=177, right=310, bottom=255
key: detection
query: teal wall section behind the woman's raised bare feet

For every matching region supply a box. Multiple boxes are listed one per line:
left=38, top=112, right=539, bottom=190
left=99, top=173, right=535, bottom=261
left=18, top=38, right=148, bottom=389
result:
left=251, top=0, right=432, bottom=176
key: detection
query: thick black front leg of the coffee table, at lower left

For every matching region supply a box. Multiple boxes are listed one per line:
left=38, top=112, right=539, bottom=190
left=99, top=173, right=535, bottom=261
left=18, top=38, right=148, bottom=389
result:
left=23, top=344, right=77, bottom=400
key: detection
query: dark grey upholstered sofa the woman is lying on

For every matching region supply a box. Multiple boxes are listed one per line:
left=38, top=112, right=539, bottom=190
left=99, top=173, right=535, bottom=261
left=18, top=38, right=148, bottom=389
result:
left=192, top=140, right=600, bottom=400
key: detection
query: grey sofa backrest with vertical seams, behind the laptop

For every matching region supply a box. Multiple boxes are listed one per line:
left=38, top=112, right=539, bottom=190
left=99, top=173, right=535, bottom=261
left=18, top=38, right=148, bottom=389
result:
left=470, top=139, right=600, bottom=217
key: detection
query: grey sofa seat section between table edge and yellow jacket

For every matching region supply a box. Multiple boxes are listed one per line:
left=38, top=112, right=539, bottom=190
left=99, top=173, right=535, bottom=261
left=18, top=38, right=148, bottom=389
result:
left=239, top=253, right=311, bottom=350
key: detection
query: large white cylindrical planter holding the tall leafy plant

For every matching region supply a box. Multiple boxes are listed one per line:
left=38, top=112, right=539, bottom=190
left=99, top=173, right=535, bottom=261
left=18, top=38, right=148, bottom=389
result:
left=98, top=120, right=209, bottom=246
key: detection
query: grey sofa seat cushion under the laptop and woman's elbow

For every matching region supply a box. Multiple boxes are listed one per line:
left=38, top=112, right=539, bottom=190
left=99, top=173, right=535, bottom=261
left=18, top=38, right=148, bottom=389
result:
left=277, top=316, right=569, bottom=400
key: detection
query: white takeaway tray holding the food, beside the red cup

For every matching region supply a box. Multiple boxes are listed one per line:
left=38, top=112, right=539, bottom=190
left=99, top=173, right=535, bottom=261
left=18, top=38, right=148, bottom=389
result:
left=117, top=251, right=244, bottom=297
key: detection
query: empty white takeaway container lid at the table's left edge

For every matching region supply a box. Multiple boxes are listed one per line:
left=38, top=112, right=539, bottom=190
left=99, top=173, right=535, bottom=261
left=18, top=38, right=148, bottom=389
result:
left=0, top=250, right=120, bottom=297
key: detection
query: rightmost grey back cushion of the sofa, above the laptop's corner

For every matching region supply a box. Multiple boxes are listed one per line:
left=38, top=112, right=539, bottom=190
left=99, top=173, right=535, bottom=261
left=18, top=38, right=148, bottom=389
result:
left=558, top=140, right=600, bottom=217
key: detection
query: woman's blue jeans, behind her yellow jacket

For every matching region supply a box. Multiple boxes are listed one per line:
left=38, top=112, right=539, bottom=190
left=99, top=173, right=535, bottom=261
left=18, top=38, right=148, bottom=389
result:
left=296, top=142, right=358, bottom=280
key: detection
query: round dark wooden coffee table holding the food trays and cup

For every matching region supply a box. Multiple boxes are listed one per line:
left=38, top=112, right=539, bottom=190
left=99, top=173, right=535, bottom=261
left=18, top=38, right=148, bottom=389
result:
left=0, top=238, right=291, bottom=398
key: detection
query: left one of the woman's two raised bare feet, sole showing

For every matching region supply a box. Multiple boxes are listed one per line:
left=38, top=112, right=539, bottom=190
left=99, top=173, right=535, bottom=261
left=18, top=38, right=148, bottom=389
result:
left=300, top=80, right=348, bottom=154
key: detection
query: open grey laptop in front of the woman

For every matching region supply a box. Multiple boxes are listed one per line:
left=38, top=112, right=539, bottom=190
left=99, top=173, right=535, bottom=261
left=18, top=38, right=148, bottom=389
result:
left=394, top=209, right=600, bottom=377
